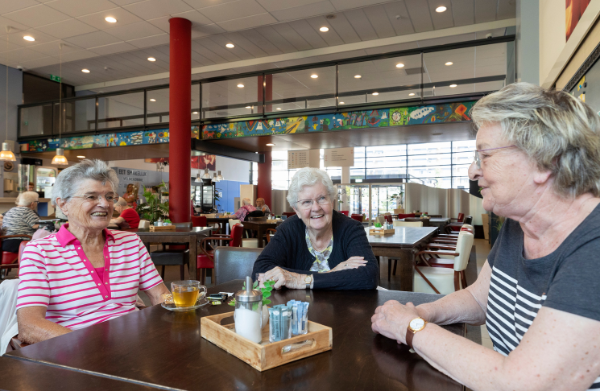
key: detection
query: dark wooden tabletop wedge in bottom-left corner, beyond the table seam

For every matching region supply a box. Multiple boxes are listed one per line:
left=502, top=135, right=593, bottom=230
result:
left=0, top=357, right=156, bottom=391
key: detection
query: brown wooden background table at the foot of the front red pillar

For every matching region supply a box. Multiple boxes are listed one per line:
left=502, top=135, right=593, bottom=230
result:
left=123, top=227, right=214, bottom=282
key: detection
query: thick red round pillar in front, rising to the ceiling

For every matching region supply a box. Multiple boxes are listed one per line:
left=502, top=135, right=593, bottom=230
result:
left=169, top=18, right=192, bottom=223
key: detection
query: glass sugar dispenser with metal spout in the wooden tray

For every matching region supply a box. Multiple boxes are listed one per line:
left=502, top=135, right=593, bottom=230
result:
left=233, top=277, right=262, bottom=343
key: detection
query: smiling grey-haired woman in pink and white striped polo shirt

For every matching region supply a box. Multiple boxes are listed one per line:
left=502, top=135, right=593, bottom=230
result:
left=17, top=160, right=169, bottom=343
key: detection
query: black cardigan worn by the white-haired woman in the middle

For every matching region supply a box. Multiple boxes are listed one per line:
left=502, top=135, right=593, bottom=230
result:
left=252, top=211, right=379, bottom=290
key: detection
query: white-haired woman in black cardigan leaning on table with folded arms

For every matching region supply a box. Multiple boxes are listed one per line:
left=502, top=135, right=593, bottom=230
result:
left=253, top=168, right=379, bottom=290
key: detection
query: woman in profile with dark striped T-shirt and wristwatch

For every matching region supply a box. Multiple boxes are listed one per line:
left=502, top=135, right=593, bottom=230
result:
left=372, top=83, right=600, bottom=391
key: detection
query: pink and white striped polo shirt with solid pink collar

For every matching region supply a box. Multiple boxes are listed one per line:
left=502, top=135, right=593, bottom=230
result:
left=17, top=224, right=162, bottom=330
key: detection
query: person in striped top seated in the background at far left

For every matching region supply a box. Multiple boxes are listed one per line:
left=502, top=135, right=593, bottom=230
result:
left=2, top=191, right=40, bottom=253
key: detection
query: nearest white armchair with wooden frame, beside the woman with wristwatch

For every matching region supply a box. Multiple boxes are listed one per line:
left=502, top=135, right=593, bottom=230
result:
left=413, top=231, right=473, bottom=295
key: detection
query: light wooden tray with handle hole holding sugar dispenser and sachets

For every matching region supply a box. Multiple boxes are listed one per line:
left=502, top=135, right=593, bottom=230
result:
left=200, top=312, right=333, bottom=372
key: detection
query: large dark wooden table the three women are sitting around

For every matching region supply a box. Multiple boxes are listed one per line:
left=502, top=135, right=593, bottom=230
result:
left=6, top=280, right=465, bottom=391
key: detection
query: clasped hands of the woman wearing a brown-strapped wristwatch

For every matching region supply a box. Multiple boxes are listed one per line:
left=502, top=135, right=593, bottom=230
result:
left=371, top=300, right=419, bottom=344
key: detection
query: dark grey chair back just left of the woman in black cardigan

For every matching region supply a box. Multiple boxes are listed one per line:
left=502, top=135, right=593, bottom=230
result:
left=214, top=247, right=262, bottom=284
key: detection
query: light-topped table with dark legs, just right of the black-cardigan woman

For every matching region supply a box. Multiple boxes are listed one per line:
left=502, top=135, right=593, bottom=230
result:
left=365, top=227, right=437, bottom=292
